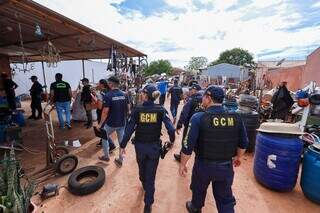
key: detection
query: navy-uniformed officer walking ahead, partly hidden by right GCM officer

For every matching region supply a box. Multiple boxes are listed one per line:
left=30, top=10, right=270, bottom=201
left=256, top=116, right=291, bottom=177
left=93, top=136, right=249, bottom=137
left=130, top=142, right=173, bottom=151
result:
left=174, top=84, right=202, bottom=162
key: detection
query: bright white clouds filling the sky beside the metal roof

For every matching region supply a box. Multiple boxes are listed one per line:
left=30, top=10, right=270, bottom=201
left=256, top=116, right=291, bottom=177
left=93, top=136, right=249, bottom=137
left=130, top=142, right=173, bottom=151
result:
left=38, top=0, right=320, bottom=67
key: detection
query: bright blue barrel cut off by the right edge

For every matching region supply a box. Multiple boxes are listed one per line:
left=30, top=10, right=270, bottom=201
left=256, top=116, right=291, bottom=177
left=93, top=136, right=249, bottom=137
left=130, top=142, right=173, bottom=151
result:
left=300, top=145, right=320, bottom=204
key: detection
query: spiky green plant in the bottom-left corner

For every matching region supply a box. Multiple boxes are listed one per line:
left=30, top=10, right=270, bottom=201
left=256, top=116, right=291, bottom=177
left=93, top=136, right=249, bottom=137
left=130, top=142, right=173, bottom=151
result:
left=0, top=148, right=36, bottom=213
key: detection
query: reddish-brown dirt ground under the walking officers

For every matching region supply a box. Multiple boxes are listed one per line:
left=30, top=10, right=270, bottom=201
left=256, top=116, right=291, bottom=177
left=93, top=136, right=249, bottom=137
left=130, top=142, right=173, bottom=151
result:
left=1, top=100, right=320, bottom=213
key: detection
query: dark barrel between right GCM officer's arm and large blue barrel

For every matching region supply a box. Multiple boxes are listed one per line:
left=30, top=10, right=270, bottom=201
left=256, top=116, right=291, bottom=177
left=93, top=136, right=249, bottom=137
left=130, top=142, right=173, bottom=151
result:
left=237, top=111, right=260, bottom=152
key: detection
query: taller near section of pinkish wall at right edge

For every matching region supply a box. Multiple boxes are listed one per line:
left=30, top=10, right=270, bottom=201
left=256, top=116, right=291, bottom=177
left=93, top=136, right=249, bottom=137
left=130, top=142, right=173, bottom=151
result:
left=302, top=47, right=320, bottom=86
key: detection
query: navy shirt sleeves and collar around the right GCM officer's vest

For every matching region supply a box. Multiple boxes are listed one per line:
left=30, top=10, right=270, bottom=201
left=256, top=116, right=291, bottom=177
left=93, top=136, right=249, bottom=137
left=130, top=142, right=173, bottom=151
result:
left=181, top=106, right=249, bottom=155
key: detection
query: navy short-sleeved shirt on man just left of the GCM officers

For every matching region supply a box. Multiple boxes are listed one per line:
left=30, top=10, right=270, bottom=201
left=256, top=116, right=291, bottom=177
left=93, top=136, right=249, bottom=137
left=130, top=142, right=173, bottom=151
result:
left=103, top=89, right=129, bottom=127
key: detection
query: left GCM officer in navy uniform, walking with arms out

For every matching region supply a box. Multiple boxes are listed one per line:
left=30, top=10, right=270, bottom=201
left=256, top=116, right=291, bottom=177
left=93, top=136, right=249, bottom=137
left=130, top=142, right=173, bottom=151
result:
left=120, top=85, right=175, bottom=212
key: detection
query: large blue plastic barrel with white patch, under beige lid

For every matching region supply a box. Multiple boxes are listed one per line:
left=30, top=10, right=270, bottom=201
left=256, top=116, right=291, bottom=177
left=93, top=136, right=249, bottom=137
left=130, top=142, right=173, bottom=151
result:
left=253, top=133, right=303, bottom=191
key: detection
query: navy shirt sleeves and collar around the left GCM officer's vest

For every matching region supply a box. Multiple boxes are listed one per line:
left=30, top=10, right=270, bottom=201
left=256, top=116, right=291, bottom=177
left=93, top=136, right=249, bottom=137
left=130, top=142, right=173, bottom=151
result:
left=120, top=101, right=175, bottom=149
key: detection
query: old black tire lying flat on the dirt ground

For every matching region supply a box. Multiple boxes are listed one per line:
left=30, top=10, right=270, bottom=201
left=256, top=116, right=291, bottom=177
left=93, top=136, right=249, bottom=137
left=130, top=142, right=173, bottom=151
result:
left=68, top=166, right=106, bottom=195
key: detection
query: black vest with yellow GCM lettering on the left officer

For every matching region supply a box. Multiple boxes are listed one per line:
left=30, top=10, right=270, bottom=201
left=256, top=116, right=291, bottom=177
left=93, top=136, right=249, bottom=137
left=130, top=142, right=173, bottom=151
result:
left=134, top=105, right=165, bottom=143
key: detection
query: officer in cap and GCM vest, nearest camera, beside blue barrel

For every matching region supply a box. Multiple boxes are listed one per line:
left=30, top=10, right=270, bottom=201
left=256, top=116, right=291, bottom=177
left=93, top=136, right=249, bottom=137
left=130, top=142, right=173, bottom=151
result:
left=179, top=86, right=248, bottom=213
